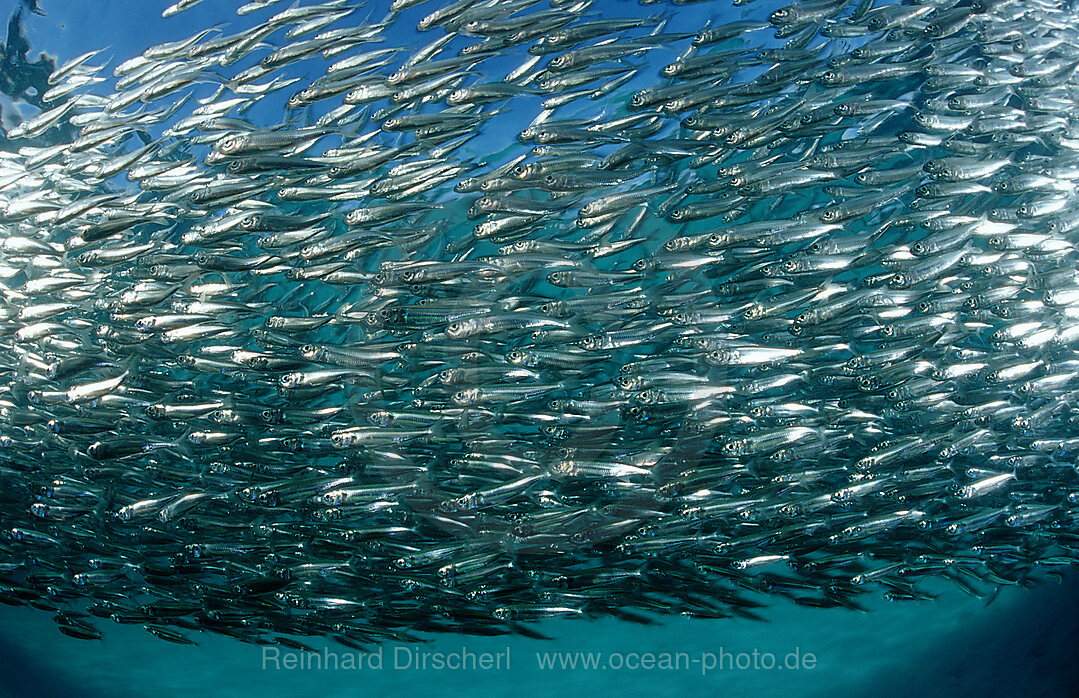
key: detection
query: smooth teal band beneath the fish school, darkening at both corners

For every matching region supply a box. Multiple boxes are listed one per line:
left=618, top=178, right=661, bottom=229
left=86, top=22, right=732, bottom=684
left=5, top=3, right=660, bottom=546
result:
left=0, top=575, right=1079, bottom=698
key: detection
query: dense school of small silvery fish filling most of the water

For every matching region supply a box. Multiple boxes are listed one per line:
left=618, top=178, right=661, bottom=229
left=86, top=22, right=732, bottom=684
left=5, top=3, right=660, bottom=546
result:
left=0, top=0, right=1079, bottom=647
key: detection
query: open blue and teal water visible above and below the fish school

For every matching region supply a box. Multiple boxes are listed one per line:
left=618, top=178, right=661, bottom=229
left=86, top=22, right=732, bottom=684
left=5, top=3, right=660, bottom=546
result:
left=0, top=0, right=1079, bottom=698
